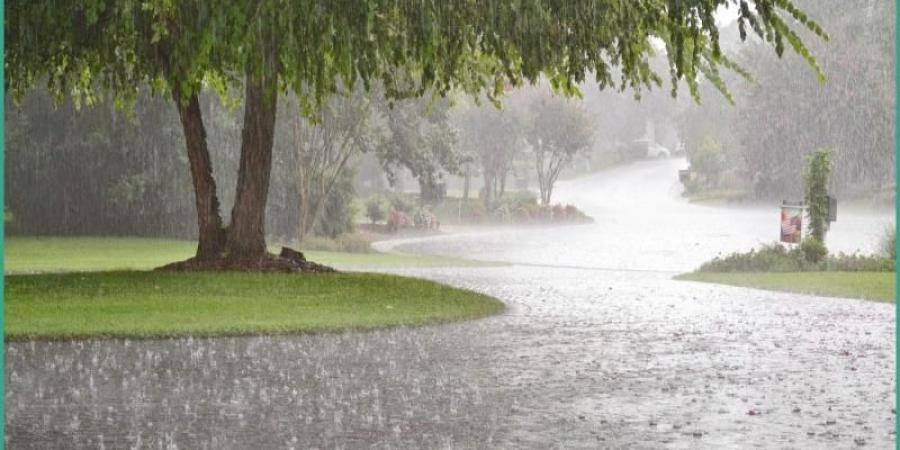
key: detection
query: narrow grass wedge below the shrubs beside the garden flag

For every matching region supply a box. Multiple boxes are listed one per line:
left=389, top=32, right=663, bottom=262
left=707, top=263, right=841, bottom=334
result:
left=675, top=272, right=896, bottom=303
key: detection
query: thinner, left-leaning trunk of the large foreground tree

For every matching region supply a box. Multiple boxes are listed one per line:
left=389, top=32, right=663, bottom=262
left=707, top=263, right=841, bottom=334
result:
left=172, top=89, right=225, bottom=261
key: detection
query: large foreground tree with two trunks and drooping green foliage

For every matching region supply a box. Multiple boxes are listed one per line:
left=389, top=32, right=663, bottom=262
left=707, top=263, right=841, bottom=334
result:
left=5, top=0, right=824, bottom=268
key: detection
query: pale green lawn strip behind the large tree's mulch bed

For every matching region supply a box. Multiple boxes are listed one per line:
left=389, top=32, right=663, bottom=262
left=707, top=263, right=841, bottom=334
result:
left=4, top=237, right=484, bottom=274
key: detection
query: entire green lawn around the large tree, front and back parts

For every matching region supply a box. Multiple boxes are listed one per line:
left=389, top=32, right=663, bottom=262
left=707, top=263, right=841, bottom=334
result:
left=4, top=237, right=503, bottom=340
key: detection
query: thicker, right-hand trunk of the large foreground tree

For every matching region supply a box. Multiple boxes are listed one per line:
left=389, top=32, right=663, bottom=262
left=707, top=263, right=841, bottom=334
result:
left=227, top=74, right=278, bottom=263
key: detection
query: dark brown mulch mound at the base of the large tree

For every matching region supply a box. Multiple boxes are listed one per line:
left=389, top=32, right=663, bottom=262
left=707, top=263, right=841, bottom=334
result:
left=154, top=247, right=337, bottom=273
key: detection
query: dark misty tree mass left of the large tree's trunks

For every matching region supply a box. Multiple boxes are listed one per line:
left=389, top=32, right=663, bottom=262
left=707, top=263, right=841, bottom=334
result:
left=5, top=91, right=196, bottom=238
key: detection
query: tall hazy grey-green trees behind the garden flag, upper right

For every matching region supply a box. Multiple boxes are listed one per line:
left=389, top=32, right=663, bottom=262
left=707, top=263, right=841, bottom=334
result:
left=680, top=0, right=896, bottom=199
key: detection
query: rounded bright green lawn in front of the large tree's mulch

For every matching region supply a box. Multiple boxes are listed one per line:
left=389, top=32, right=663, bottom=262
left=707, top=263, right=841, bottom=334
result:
left=4, top=270, right=503, bottom=340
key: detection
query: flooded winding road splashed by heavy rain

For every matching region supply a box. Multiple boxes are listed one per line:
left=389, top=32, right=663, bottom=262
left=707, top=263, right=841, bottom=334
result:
left=6, top=160, right=895, bottom=449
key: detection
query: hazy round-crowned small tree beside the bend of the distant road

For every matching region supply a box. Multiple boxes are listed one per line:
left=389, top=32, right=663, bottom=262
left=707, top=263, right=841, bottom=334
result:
left=525, top=96, right=593, bottom=205
